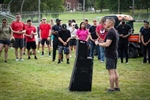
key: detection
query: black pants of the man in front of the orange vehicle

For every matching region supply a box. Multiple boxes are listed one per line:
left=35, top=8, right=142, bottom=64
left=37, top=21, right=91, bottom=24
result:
left=119, top=41, right=129, bottom=63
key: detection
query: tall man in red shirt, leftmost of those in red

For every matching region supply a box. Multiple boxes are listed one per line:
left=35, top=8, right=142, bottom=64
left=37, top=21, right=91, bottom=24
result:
left=11, top=14, right=25, bottom=61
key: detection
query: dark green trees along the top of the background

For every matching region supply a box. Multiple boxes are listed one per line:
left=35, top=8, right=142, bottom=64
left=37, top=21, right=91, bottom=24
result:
left=4, top=0, right=150, bottom=13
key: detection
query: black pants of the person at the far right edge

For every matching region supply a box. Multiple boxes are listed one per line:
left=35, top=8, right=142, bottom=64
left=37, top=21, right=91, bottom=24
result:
left=143, top=43, right=150, bottom=63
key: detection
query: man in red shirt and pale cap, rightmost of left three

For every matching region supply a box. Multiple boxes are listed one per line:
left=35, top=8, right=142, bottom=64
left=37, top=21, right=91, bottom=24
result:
left=40, top=18, right=51, bottom=57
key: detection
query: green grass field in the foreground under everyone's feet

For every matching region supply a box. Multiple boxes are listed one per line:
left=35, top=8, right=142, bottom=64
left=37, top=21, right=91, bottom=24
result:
left=0, top=49, right=150, bottom=100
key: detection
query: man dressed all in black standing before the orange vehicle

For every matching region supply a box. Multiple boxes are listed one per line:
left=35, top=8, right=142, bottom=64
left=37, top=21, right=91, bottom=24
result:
left=117, top=18, right=131, bottom=64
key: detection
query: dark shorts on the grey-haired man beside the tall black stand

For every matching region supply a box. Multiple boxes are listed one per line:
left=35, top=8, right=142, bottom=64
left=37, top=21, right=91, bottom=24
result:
left=106, top=58, right=117, bottom=69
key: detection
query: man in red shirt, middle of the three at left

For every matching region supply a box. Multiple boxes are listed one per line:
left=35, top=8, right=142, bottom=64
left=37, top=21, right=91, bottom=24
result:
left=25, top=20, right=37, bottom=59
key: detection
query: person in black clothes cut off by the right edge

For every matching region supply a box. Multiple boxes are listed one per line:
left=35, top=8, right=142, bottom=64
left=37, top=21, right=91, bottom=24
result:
left=141, top=21, right=150, bottom=64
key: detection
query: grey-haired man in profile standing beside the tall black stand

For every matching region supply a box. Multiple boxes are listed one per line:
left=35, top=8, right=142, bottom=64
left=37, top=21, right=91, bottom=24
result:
left=95, top=18, right=120, bottom=92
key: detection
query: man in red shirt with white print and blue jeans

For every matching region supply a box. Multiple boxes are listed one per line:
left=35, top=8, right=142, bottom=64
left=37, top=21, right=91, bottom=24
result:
left=96, top=18, right=107, bottom=62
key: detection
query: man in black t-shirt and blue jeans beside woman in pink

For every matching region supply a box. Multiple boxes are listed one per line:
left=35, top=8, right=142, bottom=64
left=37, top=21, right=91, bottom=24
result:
left=89, top=20, right=99, bottom=58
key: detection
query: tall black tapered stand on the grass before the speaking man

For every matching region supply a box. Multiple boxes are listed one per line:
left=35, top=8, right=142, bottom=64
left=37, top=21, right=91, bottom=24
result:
left=69, top=40, right=93, bottom=91
